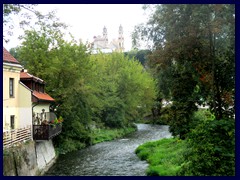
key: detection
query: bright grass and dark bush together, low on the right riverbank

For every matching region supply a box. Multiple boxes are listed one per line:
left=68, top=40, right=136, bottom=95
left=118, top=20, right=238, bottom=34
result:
left=135, top=110, right=235, bottom=176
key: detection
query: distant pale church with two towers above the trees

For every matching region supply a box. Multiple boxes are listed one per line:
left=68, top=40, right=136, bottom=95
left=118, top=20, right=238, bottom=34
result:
left=89, top=25, right=124, bottom=53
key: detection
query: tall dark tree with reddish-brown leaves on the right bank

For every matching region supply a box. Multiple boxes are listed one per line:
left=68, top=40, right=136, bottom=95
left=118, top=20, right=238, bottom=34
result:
left=136, top=5, right=235, bottom=139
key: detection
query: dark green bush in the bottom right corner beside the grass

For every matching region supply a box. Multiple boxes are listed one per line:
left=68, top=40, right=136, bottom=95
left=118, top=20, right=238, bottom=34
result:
left=178, top=119, right=235, bottom=176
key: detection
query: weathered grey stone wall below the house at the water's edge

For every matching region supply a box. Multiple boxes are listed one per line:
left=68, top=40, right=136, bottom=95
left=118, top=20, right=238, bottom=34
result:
left=3, top=140, right=56, bottom=176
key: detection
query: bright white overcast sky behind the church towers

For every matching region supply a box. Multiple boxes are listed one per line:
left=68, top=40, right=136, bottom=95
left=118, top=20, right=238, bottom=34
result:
left=3, top=4, right=147, bottom=51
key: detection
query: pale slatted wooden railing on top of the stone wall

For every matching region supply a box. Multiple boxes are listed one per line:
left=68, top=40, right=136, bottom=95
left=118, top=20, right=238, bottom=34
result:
left=3, top=126, right=32, bottom=148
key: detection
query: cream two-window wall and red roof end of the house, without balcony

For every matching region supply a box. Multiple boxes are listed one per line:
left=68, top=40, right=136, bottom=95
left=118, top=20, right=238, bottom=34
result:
left=3, top=48, right=32, bottom=130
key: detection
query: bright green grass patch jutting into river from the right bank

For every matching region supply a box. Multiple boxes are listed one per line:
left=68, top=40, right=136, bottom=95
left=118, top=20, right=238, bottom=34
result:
left=135, top=138, right=186, bottom=176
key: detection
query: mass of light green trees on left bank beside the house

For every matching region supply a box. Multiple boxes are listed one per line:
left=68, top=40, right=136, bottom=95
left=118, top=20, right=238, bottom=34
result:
left=10, top=20, right=155, bottom=152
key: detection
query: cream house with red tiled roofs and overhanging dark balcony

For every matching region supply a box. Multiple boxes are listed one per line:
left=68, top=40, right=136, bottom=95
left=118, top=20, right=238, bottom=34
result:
left=3, top=48, right=61, bottom=143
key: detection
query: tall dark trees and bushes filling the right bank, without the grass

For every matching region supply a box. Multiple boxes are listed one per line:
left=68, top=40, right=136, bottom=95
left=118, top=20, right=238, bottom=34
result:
left=133, top=4, right=235, bottom=176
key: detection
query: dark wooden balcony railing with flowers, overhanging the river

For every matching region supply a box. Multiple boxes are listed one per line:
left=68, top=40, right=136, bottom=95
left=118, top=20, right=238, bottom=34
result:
left=33, top=124, right=62, bottom=140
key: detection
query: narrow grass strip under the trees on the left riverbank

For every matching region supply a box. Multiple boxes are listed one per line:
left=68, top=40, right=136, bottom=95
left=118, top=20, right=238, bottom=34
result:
left=92, top=127, right=136, bottom=144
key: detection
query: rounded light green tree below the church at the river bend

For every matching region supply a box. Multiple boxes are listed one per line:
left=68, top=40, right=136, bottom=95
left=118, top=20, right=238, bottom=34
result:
left=89, top=53, right=155, bottom=127
